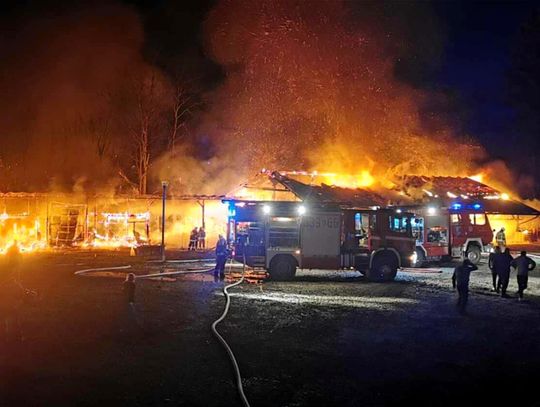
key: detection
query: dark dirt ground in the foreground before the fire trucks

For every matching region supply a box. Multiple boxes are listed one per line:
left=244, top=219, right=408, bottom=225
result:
left=0, top=252, right=540, bottom=406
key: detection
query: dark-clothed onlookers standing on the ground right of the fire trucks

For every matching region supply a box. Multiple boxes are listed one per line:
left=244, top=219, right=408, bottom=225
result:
left=452, top=246, right=536, bottom=314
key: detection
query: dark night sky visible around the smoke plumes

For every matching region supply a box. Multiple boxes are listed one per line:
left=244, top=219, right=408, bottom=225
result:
left=0, top=1, right=540, bottom=196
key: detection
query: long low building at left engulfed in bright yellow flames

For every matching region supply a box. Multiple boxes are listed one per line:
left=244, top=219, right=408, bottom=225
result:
left=0, top=193, right=226, bottom=253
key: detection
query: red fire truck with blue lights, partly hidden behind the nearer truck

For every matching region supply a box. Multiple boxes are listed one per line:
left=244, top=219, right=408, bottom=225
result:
left=407, top=202, right=493, bottom=267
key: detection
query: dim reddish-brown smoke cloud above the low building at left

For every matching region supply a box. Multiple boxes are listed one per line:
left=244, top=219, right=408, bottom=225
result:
left=0, top=5, right=160, bottom=194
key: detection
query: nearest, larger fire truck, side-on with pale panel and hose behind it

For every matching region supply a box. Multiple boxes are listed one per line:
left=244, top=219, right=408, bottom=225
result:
left=224, top=200, right=415, bottom=281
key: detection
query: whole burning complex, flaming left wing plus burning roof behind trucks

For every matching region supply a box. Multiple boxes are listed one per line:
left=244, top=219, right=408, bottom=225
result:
left=0, top=170, right=540, bottom=253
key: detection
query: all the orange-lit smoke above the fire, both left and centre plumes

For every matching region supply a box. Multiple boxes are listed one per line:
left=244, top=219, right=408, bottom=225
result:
left=0, top=0, right=527, bottom=199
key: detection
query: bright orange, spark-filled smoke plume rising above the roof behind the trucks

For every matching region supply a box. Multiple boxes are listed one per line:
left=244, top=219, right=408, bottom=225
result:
left=196, top=0, right=484, bottom=185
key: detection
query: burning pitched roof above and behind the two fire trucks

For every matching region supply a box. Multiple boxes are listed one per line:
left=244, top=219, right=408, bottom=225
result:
left=238, top=170, right=540, bottom=245
